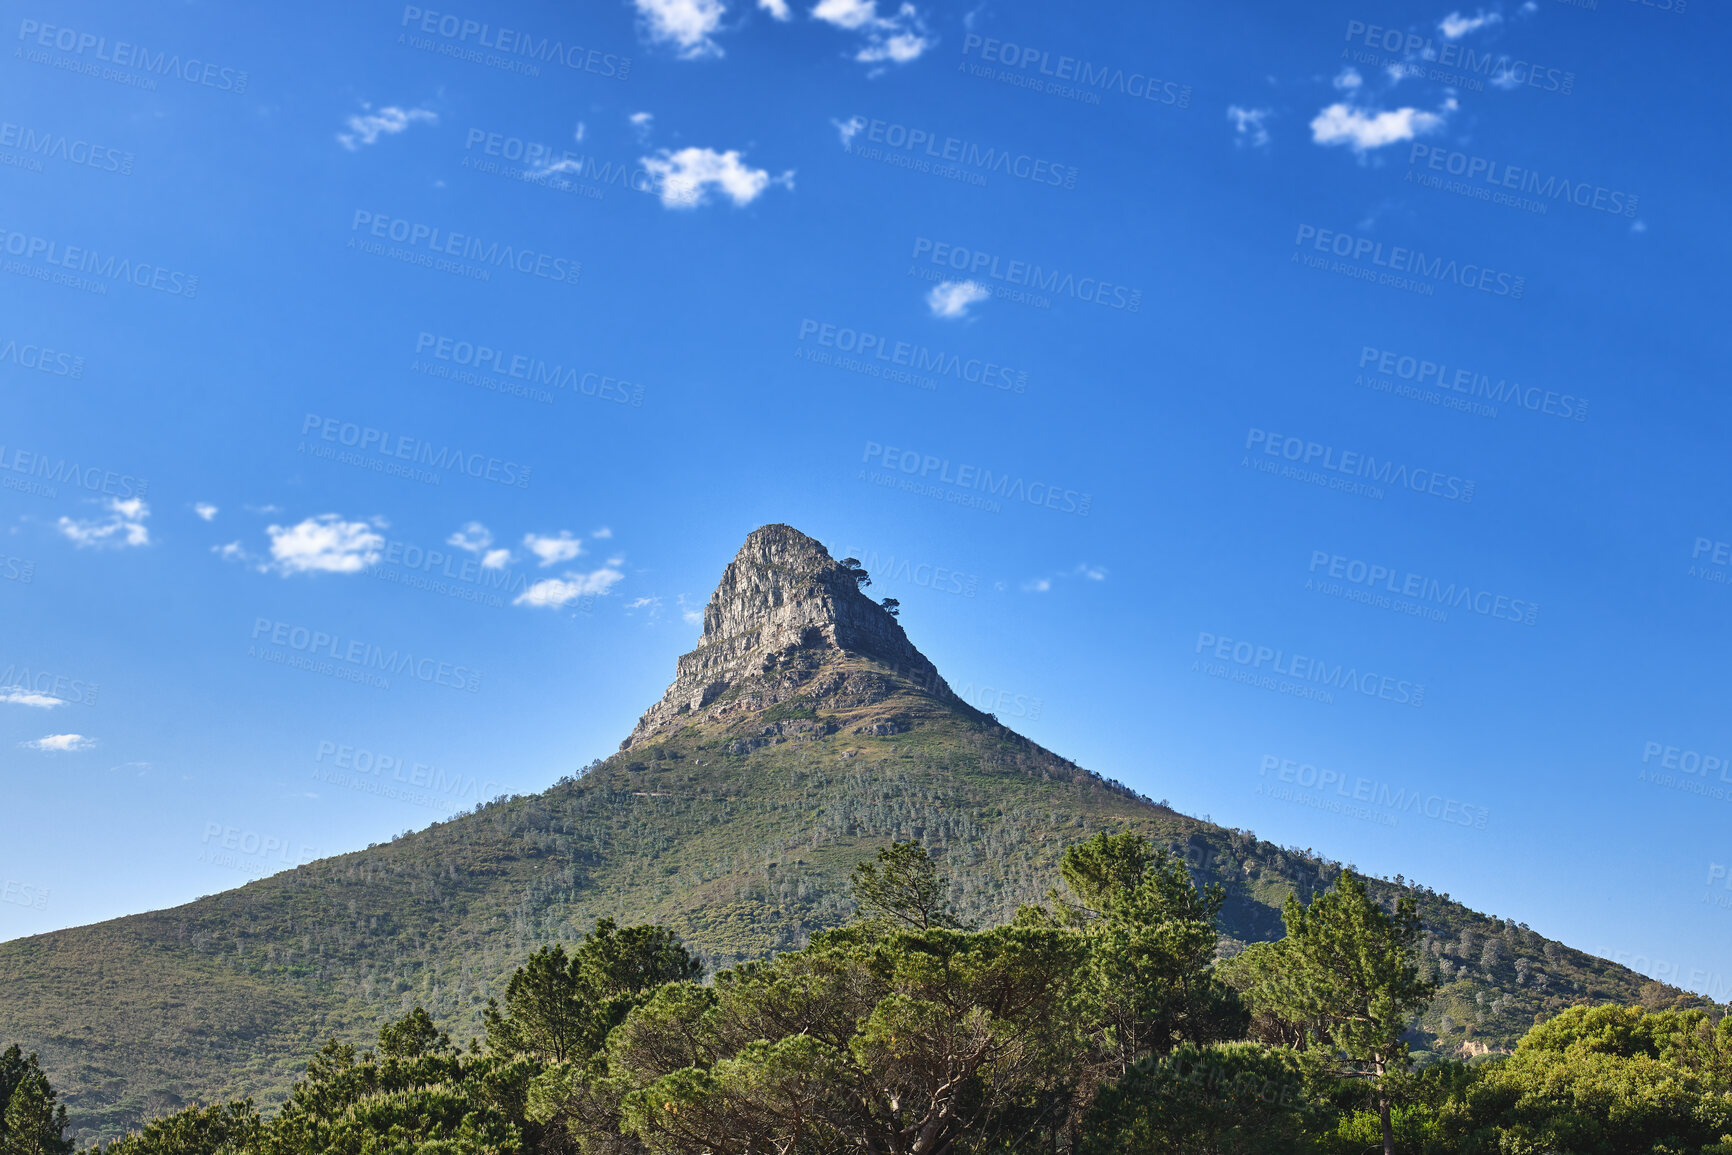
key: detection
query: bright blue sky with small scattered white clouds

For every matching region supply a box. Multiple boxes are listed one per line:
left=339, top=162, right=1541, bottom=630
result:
left=0, top=0, right=1732, bottom=999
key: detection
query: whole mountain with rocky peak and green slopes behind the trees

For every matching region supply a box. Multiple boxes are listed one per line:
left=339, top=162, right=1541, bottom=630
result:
left=0, top=525, right=1694, bottom=1139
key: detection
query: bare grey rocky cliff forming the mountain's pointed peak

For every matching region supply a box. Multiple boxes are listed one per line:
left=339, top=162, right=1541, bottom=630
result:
left=620, top=525, right=960, bottom=750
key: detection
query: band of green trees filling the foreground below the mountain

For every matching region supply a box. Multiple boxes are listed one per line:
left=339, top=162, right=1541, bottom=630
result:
left=0, top=833, right=1732, bottom=1155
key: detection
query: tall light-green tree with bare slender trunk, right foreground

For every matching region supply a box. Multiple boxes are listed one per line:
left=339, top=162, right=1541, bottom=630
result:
left=1233, top=871, right=1436, bottom=1155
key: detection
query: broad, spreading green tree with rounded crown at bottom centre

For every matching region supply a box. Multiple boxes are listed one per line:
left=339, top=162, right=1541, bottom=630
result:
left=606, top=925, right=1083, bottom=1155
